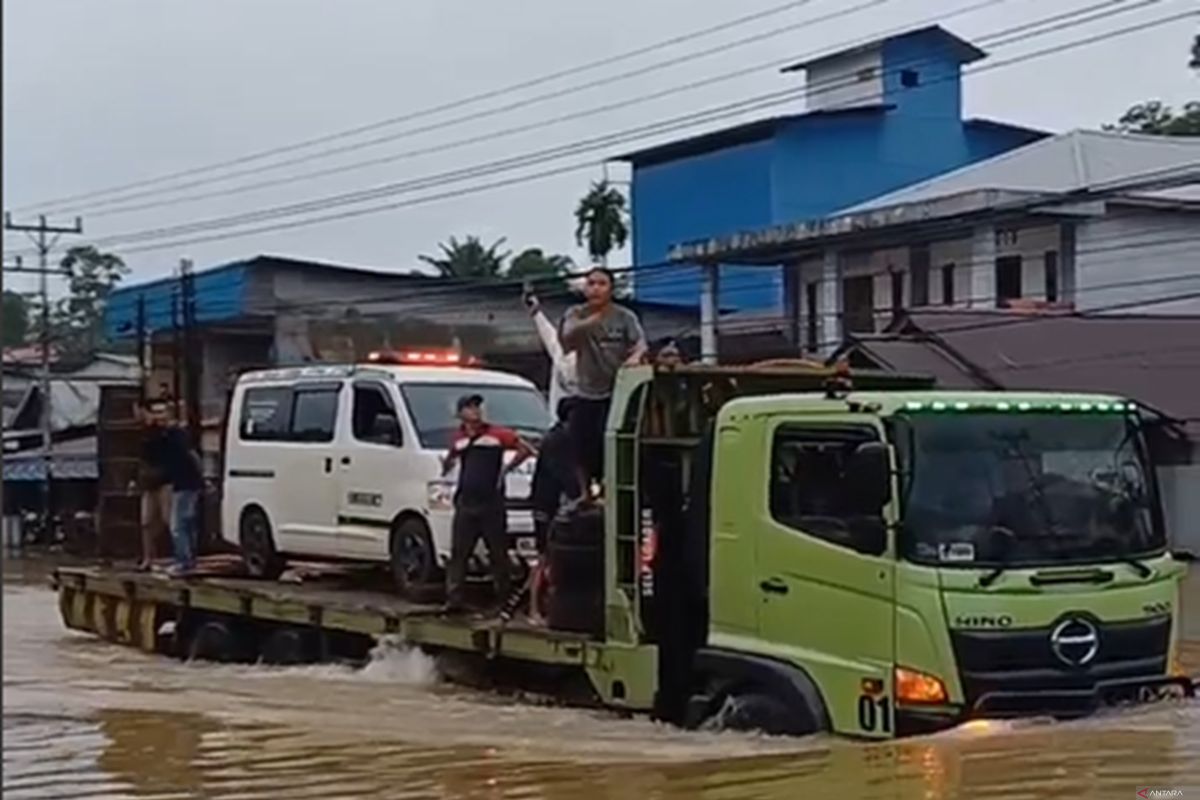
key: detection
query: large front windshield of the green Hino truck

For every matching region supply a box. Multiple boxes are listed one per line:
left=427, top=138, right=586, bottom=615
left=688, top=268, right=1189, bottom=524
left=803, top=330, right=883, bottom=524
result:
left=894, top=410, right=1165, bottom=567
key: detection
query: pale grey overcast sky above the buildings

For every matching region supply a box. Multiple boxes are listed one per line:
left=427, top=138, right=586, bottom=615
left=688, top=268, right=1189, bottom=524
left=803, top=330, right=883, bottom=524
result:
left=2, top=0, right=1200, bottom=288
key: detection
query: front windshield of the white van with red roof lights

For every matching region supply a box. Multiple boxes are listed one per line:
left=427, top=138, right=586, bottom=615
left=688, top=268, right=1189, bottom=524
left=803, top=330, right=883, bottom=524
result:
left=400, top=384, right=552, bottom=450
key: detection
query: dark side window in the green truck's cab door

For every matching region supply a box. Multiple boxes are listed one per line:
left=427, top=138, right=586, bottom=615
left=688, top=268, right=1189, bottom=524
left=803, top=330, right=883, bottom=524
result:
left=770, top=426, right=878, bottom=547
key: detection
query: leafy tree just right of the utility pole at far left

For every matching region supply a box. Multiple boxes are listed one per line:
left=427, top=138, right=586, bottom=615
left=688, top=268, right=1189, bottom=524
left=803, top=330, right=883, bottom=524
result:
left=50, top=245, right=130, bottom=354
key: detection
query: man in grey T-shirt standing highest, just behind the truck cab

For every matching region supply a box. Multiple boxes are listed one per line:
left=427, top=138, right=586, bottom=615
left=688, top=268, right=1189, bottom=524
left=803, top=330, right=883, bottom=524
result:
left=562, top=266, right=647, bottom=495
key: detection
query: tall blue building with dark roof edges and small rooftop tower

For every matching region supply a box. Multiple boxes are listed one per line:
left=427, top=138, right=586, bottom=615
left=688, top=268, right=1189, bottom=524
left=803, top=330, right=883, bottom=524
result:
left=619, top=26, right=1045, bottom=311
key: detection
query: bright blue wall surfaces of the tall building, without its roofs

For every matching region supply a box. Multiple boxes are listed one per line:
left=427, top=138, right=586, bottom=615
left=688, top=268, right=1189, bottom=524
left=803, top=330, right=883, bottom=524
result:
left=632, top=29, right=1039, bottom=311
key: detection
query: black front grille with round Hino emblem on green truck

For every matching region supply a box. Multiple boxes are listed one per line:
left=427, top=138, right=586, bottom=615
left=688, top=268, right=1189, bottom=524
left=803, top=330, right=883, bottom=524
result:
left=950, top=615, right=1171, bottom=705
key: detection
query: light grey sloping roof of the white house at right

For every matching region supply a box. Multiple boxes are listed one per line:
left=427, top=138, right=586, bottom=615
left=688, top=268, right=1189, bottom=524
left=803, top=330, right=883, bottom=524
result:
left=834, top=131, right=1200, bottom=213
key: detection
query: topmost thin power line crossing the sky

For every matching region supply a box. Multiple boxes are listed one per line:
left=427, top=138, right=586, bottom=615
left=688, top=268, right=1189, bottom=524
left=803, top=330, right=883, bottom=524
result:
left=7, top=0, right=844, bottom=215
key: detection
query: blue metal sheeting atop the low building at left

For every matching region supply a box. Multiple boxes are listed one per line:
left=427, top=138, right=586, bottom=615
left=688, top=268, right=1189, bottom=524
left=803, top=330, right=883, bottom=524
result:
left=104, top=261, right=247, bottom=339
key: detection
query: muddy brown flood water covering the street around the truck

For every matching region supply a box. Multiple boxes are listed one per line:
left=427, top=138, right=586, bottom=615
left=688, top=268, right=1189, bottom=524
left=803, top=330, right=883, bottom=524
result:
left=4, top=560, right=1200, bottom=800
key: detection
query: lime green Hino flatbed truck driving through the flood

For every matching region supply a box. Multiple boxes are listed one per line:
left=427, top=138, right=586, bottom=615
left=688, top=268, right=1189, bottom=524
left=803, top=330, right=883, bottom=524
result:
left=56, top=363, right=1194, bottom=739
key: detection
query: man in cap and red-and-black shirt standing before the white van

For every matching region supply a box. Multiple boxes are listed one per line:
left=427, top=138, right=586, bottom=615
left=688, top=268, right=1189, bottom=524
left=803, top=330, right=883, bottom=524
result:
left=442, top=395, right=533, bottom=610
